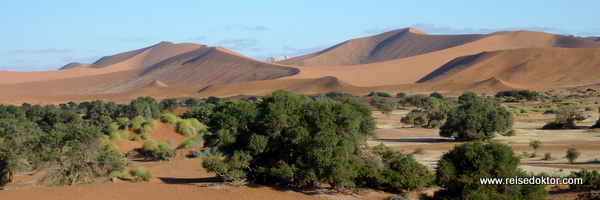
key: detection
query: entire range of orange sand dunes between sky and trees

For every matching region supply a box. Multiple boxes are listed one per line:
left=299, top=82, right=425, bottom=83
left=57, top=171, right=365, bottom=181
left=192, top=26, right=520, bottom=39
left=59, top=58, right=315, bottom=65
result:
left=0, top=28, right=600, bottom=104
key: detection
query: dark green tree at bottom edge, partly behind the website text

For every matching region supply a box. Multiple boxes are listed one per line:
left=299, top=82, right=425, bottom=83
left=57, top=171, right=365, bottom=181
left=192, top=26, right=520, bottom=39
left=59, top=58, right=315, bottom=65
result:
left=435, top=141, right=548, bottom=199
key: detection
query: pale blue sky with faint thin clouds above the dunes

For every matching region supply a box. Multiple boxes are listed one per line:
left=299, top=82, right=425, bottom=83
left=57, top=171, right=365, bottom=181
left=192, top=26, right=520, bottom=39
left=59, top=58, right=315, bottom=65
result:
left=0, top=0, right=600, bottom=71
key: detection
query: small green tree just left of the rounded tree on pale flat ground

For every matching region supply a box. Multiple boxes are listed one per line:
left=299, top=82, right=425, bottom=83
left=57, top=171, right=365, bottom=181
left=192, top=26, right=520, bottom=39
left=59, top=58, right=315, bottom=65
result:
left=400, top=97, right=450, bottom=128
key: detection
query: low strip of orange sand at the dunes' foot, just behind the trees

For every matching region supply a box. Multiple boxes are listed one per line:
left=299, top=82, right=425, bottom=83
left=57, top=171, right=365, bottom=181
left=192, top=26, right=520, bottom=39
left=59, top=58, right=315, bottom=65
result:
left=0, top=77, right=548, bottom=105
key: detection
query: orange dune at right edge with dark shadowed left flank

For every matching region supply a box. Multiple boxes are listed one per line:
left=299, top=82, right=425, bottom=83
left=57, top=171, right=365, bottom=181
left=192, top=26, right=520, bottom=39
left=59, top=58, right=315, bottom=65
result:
left=419, top=48, right=600, bottom=87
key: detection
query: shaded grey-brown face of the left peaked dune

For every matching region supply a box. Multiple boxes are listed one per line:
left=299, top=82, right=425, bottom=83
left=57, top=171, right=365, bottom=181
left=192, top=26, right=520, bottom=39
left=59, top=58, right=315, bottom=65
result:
left=101, top=47, right=298, bottom=92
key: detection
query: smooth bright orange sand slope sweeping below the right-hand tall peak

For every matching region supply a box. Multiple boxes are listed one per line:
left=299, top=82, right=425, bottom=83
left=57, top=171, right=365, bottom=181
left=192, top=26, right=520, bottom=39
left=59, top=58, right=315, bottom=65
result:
left=283, top=31, right=600, bottom=87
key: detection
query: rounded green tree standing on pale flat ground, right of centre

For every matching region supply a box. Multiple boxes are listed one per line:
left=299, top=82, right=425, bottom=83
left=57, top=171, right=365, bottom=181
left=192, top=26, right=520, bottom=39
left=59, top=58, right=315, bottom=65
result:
left=440, top=97, right=513, bottom=141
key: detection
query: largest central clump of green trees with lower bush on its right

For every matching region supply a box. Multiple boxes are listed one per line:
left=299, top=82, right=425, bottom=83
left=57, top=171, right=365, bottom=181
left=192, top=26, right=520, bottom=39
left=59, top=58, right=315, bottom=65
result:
left=202, top=90, right=433, bottom=190
